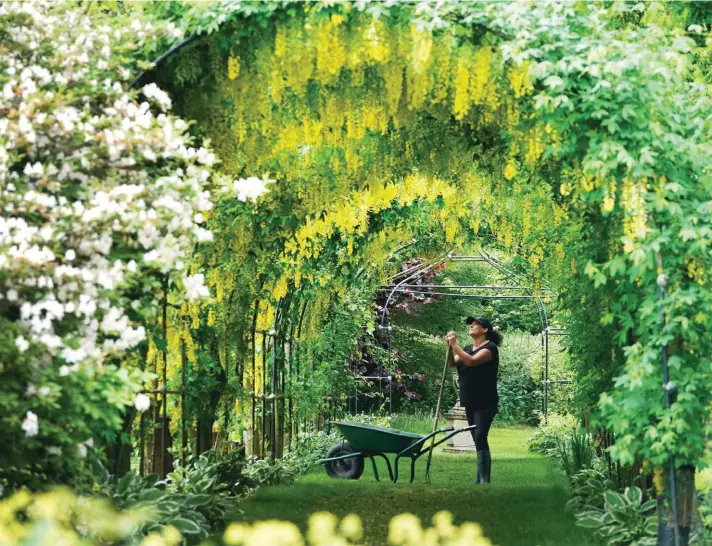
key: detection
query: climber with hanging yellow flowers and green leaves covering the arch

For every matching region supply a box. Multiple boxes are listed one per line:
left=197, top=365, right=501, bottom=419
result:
left=138, top=2, right=712, bottom=540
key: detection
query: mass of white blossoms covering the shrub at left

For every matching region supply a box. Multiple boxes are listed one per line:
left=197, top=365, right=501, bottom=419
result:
left=0, top=1, right=266, bottom=436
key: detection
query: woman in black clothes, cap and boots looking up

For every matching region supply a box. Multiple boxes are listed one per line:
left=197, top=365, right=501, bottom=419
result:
left=446, top=317, right=503, bottom=483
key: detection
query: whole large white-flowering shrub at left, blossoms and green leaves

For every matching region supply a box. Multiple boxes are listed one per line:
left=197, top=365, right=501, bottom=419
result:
left=0, top=2, right=272, bottom=486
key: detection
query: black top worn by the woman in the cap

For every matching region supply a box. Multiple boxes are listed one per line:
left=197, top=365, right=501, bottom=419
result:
left=457, top=341, right=499, bottom=409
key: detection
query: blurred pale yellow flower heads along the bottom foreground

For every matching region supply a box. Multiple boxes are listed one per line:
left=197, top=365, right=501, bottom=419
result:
left=0, top=489, right=492, bottom=546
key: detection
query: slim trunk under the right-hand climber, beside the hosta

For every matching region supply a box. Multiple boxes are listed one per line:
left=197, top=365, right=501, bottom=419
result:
left=658, top=466, right=697, bottom=546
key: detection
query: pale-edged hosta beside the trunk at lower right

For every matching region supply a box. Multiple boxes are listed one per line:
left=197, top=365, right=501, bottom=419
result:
left=576, top=487, right=658, bottom=546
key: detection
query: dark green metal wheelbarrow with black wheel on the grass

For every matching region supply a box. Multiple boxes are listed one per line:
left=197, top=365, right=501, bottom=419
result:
left=319, top=421, right=475, bottom=483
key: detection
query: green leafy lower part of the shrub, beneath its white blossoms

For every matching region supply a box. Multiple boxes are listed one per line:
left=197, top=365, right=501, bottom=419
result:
left=0, top=340, right=147, bottom=492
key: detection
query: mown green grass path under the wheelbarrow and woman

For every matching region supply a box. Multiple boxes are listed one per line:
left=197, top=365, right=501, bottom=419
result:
left=241, top=428, right=598, bottom=546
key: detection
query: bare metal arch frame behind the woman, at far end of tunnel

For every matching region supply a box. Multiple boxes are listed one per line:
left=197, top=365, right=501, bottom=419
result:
left=372, top=251, right=572, bottom=420
